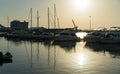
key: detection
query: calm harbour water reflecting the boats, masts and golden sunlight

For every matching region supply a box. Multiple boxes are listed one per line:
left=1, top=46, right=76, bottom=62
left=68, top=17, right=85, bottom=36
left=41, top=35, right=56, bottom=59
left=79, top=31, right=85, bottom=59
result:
left=0, top=38, right=120, bottom=74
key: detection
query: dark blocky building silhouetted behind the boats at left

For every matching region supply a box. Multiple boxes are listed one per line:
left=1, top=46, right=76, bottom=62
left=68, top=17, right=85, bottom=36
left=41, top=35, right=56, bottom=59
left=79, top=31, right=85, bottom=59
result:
left=10, top=20, right=28, bottom=30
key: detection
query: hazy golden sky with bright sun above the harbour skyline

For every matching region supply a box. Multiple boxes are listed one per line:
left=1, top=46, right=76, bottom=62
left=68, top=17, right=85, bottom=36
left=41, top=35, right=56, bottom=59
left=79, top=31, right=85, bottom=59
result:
left=0, top=0, right=120, bottom=29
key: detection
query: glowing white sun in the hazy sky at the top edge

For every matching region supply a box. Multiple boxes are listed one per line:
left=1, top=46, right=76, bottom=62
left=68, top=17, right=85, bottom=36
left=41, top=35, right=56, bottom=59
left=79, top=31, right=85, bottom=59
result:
left=74, top=0, right=90, bottom=9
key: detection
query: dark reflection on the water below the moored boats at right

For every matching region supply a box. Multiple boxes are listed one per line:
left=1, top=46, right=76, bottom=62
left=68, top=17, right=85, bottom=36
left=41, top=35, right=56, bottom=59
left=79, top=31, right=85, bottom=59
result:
left=85, top=43, right=120, bottom=58
